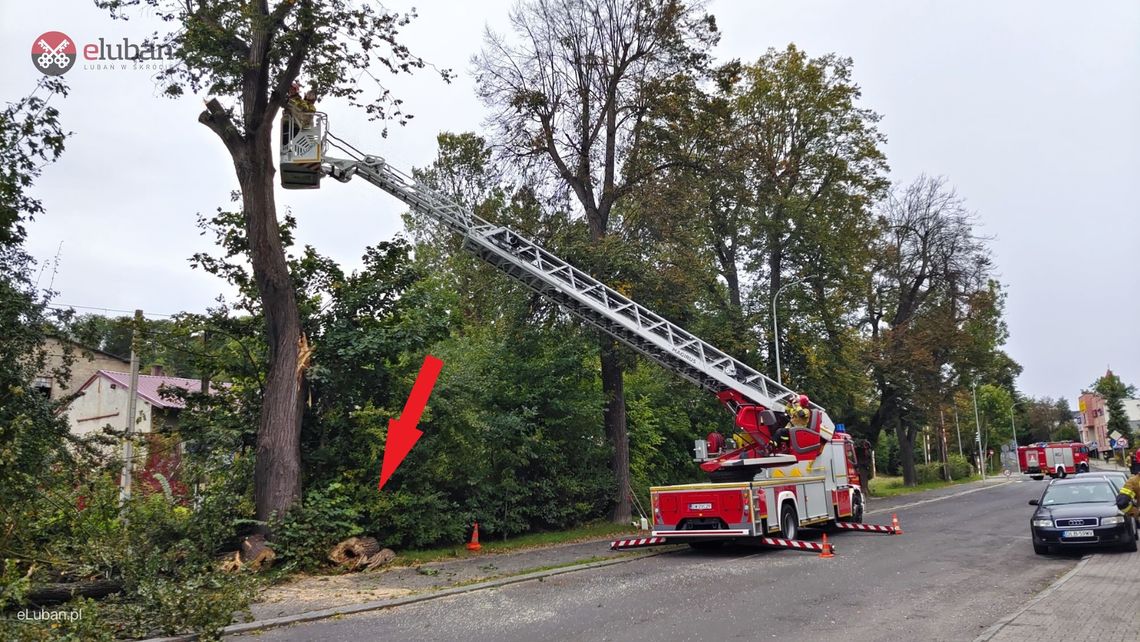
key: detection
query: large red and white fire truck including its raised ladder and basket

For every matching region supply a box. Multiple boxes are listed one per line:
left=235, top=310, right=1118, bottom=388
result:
left=280, top=112, right=861, bottom=547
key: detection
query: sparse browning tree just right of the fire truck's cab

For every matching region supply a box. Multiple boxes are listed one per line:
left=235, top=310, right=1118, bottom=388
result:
left=866, top=176, right=1017, bottom=485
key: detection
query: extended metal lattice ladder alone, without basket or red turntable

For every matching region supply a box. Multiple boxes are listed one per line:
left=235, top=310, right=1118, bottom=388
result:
left=323, top=156, right=833, bottom=426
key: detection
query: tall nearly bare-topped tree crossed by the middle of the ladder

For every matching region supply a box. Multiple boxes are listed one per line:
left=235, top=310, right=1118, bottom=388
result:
left=475, top=0, right=717, bottom=522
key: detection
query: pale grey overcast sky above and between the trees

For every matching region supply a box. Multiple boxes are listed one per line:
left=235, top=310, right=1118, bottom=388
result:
left=0, top=0, right=1140, bottom=407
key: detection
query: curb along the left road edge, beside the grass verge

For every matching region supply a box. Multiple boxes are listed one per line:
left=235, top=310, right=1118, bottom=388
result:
left=141, top=550, right=670, bottom=642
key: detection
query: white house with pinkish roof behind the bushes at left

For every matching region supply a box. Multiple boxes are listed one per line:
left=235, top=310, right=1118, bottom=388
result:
left=67, top=368, right=212, bottom=434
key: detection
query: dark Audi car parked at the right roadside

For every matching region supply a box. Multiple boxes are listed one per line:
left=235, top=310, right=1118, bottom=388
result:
left=1029, top=476, right=1137, bottom=555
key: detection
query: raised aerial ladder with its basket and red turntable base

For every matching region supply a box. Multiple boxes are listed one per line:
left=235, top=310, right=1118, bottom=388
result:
left=280, top=112, right=836, bottom=480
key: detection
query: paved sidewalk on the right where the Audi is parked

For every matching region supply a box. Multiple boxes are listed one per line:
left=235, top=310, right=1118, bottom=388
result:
left=975, top=462, right=1140, bottom=642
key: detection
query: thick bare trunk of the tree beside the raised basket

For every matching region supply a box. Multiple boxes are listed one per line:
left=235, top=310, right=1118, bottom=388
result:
left=234, top=128, right=308, bottom=521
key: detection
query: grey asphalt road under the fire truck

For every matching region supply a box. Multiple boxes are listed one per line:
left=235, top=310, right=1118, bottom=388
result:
left=233, top=480, right=1080, bottom=642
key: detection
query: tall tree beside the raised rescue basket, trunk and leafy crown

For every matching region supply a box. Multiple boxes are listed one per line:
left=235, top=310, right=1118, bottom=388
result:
left=96, top=0, right=447, bottom=521
